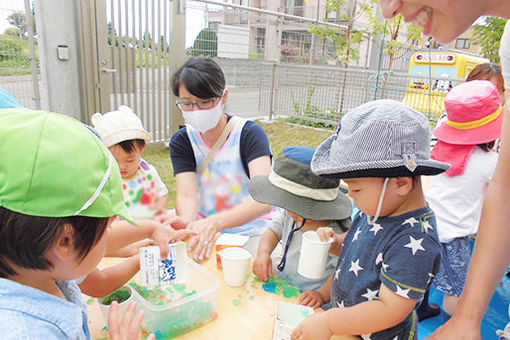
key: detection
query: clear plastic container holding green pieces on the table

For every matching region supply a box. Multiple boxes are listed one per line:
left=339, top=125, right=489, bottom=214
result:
left=130, top=259, right=220, bottom=339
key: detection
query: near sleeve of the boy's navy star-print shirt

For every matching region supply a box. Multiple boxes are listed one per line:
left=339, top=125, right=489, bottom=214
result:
left=379, top=232, right=441, bottom=300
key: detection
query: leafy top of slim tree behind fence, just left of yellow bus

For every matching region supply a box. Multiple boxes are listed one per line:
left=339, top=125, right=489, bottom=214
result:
left=361, top=0, right=423, bottom=70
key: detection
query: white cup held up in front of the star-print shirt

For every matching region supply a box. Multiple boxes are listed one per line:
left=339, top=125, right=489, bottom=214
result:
left=298, top=231, right=333, bottom=279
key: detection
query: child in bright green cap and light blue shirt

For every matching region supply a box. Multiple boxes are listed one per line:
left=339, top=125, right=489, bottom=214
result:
left=0, top=109, right=182, bottom=339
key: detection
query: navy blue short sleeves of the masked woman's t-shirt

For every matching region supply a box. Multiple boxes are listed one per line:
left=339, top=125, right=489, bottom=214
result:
left=169, top=115, right=272, bottom=177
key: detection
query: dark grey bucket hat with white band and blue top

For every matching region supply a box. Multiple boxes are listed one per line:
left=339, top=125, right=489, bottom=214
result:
left=249, top=146, right=352, bottom=220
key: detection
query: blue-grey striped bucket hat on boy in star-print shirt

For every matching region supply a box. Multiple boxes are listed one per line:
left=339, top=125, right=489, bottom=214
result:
left=311, top=99, right=450, bottom=178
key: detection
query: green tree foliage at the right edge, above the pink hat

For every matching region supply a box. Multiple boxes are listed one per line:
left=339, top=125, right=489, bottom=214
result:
left=472, top=17, right=507, bottom=63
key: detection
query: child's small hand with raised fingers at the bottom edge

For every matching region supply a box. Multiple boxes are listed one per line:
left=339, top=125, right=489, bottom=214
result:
left=108, top=301, right=156, bottom=340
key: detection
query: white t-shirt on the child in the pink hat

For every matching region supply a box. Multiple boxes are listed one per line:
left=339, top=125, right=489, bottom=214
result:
left=425, top=147, right=498, bottom=243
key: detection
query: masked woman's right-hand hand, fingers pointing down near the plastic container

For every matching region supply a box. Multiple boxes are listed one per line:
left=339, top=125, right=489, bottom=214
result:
left=187, top=216, right=219, bottom=261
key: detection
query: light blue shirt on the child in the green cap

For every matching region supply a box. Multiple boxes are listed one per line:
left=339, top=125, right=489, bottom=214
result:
left=0, top=278, right=90, bottom=340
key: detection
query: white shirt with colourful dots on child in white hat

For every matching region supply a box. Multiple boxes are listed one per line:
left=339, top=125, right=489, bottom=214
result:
left=122, top=159, right=168, bottom=218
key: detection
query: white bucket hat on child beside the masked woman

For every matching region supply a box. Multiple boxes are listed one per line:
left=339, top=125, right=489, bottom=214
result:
left=92, top=105, right=151, bottom=147
